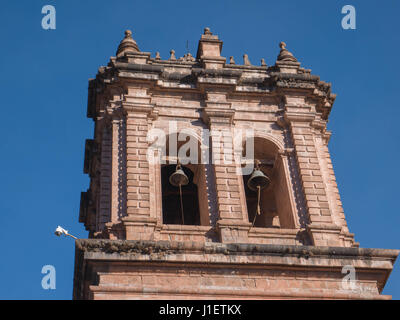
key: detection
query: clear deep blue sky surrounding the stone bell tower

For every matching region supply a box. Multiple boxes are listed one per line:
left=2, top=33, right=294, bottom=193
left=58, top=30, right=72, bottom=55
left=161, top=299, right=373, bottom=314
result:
left=0, top=0, right=400, bottom=299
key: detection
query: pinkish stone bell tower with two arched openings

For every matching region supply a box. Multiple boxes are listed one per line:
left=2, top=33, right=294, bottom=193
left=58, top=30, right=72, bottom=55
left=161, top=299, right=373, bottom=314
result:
left=74, top=28, right=398, bottom=299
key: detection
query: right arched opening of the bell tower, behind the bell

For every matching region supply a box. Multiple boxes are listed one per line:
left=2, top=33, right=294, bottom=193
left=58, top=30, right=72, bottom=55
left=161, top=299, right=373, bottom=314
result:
left=243, top=137, right=294, bottom=228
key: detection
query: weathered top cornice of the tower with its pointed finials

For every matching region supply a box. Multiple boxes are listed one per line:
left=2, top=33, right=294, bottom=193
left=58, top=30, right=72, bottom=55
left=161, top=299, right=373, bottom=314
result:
left=87, top=28, right=335, bottom=121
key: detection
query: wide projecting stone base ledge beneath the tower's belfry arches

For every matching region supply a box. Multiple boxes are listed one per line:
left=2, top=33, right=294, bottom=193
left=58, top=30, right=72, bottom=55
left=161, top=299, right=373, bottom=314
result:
left=74, top=239, right=399, bottom=299
